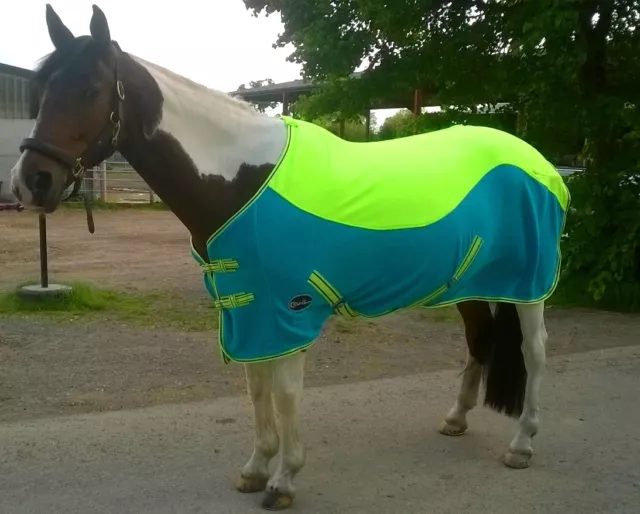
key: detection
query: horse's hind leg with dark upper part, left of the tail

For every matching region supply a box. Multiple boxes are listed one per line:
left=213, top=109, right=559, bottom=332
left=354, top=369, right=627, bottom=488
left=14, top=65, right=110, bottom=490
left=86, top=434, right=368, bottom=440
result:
left=440, top=301, right=493, bottom=435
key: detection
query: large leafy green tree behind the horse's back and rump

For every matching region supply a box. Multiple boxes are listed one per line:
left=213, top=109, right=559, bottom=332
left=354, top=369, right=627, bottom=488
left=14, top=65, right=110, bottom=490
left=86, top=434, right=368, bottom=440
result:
left=244, top=0, right=640, bottom=301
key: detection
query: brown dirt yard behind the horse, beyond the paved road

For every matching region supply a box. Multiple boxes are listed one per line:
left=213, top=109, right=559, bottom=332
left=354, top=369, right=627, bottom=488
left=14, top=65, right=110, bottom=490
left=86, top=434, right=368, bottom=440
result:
left=0, top=210, right=640, bottom=422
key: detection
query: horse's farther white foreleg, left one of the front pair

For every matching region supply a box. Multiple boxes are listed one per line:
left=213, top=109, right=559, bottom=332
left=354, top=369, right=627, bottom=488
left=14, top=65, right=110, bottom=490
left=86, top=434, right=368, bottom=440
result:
left=236, top=362, right=278, bottom=493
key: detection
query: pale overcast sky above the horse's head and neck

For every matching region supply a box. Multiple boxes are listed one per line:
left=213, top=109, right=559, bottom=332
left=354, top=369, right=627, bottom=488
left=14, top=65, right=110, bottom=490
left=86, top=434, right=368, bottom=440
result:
left=0, top=0, right=396, bottom=123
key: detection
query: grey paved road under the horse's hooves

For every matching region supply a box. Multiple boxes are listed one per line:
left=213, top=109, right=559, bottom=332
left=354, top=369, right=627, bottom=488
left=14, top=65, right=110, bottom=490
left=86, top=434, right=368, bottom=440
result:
left=0, top=346, right=640, bottom=514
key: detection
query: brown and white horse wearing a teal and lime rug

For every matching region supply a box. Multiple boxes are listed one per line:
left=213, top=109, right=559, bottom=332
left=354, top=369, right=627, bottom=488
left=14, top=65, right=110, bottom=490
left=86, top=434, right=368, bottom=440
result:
left=11, top=5, right=569, bottom=510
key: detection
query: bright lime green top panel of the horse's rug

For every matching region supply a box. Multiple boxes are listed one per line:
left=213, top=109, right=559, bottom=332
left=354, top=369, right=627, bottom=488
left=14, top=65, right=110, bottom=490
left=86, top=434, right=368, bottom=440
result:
left=269, top=117, right=569, bottom=230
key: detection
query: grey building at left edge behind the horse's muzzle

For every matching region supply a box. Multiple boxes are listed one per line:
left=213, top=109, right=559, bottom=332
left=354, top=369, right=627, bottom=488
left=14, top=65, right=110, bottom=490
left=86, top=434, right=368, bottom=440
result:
left=0, top=63, right=33, bottom=201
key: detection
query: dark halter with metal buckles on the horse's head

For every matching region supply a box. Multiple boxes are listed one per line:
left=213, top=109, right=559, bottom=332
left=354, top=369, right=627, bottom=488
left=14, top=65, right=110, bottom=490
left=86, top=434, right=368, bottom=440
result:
left=20, top=42, right=125, bottom=234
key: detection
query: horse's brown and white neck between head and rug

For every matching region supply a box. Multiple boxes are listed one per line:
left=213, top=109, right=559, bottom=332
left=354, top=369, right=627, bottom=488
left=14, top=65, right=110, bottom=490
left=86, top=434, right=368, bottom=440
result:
left=121, top=61, right=287, bottom=258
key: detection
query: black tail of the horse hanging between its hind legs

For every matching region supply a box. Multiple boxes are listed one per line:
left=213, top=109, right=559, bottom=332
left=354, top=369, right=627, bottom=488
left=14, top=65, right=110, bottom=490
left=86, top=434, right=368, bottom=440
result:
left=472, top=303, right=527, bottom=417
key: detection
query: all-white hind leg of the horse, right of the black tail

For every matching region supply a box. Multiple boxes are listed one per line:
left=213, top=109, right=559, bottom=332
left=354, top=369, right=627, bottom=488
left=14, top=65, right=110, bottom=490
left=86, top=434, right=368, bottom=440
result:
left=505, top=302, right=548, bottom=468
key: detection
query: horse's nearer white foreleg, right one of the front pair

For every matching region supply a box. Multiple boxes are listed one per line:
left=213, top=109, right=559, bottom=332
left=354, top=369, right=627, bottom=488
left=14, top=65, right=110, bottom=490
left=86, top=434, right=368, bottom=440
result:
left=262, top=352, right=305, bottom=510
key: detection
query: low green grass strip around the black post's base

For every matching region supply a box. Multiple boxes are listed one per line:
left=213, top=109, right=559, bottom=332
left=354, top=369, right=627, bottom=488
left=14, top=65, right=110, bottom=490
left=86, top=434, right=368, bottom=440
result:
left=0, top=282, right=218, bottom=332
